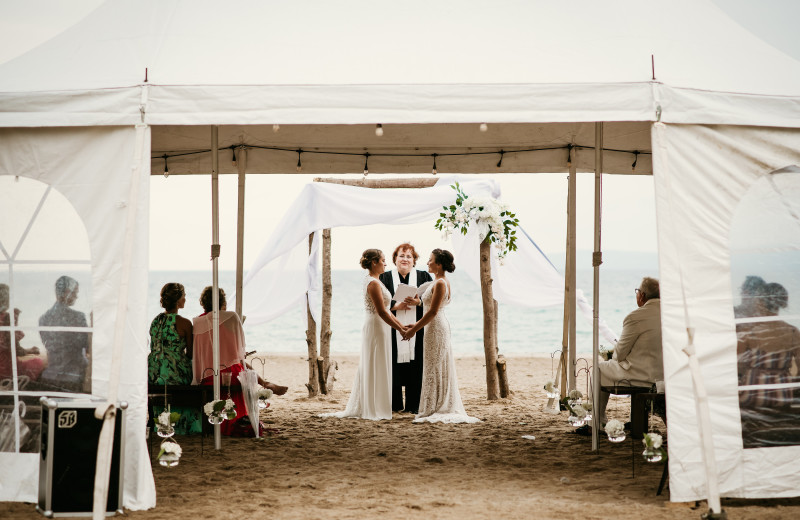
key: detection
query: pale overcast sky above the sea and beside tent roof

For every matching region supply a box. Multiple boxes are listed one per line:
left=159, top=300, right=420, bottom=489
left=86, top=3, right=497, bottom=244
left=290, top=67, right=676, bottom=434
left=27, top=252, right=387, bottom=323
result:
left=0, top=0, right=800, bottom=270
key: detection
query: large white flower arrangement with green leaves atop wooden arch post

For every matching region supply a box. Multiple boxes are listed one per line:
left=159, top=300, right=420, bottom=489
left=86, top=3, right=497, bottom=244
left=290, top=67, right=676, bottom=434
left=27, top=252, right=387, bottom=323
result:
left=434, top=183, right=519, bottom=264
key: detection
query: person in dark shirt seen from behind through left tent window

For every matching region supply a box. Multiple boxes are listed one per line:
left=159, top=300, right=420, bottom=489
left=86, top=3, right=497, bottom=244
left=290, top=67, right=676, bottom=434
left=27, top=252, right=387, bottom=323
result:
left=39, top=276, right=91, bottom=392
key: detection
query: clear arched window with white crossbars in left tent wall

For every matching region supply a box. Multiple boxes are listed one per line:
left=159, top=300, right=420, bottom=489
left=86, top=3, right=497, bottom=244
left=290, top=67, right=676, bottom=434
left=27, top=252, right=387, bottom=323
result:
left=0, top=176, right=92, bottom=453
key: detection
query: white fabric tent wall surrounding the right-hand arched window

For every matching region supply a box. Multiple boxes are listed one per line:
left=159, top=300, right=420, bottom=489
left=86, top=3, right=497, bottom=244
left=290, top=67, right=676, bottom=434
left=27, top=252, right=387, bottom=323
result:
left=653, top=124, right=800, bottom=502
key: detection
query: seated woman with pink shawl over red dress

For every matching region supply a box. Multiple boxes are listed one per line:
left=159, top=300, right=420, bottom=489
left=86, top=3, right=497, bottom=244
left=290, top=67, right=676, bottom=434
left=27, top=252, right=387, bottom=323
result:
left=192, top=286, right=287, bottom=436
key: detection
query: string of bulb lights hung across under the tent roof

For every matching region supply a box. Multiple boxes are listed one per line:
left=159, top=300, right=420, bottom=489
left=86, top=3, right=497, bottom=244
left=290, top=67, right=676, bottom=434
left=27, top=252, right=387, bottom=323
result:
left=151, top=124, right=652, bottom=177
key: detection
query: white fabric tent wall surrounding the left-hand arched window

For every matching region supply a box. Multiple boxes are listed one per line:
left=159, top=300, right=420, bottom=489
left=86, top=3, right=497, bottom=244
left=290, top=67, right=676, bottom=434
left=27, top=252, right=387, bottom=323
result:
left=0, top=127, right=155, bottom=509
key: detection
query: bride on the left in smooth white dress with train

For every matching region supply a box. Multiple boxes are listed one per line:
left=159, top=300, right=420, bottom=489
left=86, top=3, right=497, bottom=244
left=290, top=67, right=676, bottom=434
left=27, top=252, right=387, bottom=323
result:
left=320, top=249, right=408, bottom=421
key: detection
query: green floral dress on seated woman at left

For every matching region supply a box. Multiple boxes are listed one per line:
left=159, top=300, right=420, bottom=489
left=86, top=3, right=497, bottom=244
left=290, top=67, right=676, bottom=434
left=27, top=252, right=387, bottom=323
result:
left=147, top=313, right=202, bottom=435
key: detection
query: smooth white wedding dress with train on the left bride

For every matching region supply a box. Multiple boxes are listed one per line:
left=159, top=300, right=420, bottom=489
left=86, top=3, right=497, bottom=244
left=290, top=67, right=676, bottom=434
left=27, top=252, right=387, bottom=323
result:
left=320, top=275, right=392, bottom=421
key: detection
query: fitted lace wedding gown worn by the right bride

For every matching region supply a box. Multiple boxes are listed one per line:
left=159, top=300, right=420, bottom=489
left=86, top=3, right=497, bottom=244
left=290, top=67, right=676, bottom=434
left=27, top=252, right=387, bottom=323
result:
left=414, top=280, right=480, bottom=423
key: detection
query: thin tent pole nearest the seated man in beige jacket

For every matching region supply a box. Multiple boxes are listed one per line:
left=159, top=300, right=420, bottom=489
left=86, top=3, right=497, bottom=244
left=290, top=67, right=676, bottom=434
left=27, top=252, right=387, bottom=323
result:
left=592, top=122, right=603, bottom=451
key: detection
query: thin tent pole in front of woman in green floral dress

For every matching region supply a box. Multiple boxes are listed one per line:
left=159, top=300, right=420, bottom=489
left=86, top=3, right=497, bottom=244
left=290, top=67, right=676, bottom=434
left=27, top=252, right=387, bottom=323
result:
left=211, top=125, right=222, bottom=450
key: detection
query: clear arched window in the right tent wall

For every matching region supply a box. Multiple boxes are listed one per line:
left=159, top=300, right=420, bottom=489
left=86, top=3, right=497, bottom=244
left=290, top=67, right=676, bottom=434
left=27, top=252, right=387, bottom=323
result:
left=730, top=166, right=800, bottom=449
